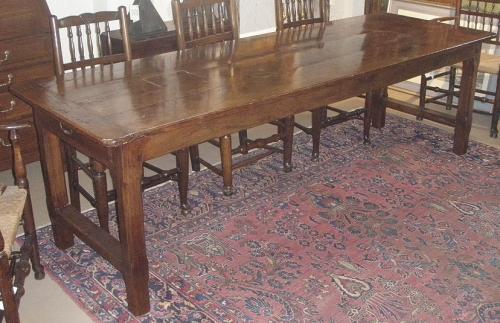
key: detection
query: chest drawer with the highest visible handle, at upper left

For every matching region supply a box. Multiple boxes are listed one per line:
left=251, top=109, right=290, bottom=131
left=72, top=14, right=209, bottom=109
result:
left=0, top=34, right=52, bottom=70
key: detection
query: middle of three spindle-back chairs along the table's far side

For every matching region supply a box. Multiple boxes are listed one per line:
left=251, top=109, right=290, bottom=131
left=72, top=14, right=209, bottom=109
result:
left=172, top=0, right=294, bottom=195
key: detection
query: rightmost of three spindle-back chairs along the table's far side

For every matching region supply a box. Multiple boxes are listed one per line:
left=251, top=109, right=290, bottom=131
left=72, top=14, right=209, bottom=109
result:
left=274, top=0, right=365, bottom=159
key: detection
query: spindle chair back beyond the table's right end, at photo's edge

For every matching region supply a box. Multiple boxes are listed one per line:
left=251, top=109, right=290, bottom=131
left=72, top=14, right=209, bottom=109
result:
left=455, top=0, right=500, bottom=45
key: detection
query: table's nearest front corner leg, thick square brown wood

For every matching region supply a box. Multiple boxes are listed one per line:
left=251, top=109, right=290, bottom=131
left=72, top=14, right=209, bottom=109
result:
left=110, top=140, right=149, bottom=315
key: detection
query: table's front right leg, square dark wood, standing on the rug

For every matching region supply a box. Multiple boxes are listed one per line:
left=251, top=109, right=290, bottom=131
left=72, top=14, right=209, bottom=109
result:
left=453, top=50, right=481, bottom=155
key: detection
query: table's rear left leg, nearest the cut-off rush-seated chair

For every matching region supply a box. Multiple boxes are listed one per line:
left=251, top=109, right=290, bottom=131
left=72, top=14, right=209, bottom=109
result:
left=35, top=120, right=74, bottom=249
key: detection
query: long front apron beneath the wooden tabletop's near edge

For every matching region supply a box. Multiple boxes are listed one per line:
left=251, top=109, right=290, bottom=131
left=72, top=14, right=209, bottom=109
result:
left=144, top=43, right=481, bottom=160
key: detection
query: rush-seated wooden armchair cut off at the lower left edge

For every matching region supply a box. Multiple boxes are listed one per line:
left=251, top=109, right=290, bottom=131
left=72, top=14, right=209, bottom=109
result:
left=0, top=124, right=45, bottom=323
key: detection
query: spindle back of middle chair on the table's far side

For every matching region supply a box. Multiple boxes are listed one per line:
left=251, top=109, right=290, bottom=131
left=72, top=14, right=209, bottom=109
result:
left=172, top=0, right=239, bottom=49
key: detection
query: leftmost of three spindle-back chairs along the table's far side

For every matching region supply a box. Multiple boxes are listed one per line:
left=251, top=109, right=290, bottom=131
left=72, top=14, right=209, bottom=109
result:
left=50, top=6, right=189, bottom=231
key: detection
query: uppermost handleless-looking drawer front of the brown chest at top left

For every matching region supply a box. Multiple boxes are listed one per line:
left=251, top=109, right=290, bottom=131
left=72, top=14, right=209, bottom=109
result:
left=0, top=11, right=40, bottom=39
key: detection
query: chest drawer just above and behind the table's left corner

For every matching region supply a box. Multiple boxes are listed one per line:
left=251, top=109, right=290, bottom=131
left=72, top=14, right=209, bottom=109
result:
left=0, top=60, right=54, bottom=92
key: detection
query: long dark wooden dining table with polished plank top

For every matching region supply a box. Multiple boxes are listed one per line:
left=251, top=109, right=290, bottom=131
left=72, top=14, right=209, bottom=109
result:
left=11, top=14, right=490, bottom=314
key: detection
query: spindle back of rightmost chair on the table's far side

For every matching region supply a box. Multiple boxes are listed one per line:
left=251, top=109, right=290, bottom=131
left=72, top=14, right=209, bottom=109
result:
left=274, top=0, right=330, bottom=30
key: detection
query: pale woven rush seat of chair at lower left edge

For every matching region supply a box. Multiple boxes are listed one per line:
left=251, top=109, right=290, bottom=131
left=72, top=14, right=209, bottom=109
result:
left=0, top=186, right=27, bottom=256
